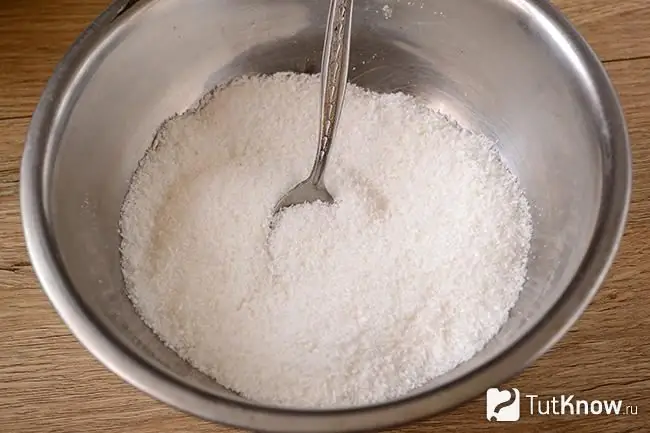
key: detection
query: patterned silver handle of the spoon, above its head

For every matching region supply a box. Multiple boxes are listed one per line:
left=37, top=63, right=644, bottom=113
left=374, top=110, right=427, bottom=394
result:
left=309, top=0, right=353, bottom=185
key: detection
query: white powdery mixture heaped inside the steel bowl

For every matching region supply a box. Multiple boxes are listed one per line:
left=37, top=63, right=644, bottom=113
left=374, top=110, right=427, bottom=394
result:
left=121, top=73, right=532, bottom=408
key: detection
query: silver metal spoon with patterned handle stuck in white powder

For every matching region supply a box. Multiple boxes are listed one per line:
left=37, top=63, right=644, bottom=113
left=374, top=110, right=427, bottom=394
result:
left=273, top=0, right=353, bottom=215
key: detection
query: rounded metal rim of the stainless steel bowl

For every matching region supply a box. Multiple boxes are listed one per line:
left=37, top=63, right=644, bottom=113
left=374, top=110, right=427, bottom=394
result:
left=20, top=0, right=632, bottom=433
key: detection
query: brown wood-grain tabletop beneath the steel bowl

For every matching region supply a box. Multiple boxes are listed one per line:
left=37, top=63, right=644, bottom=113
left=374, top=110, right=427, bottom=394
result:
left=0, top=0, right=650, bottom=433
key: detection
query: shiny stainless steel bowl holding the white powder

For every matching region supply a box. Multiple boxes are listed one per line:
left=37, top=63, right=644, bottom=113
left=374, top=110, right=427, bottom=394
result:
left=21, top=0, right=631, bottom=432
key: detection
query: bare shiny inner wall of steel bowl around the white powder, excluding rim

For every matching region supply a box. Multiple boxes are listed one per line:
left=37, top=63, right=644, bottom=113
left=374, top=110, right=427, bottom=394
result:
left=45, top=0, right=611, bottom=408
